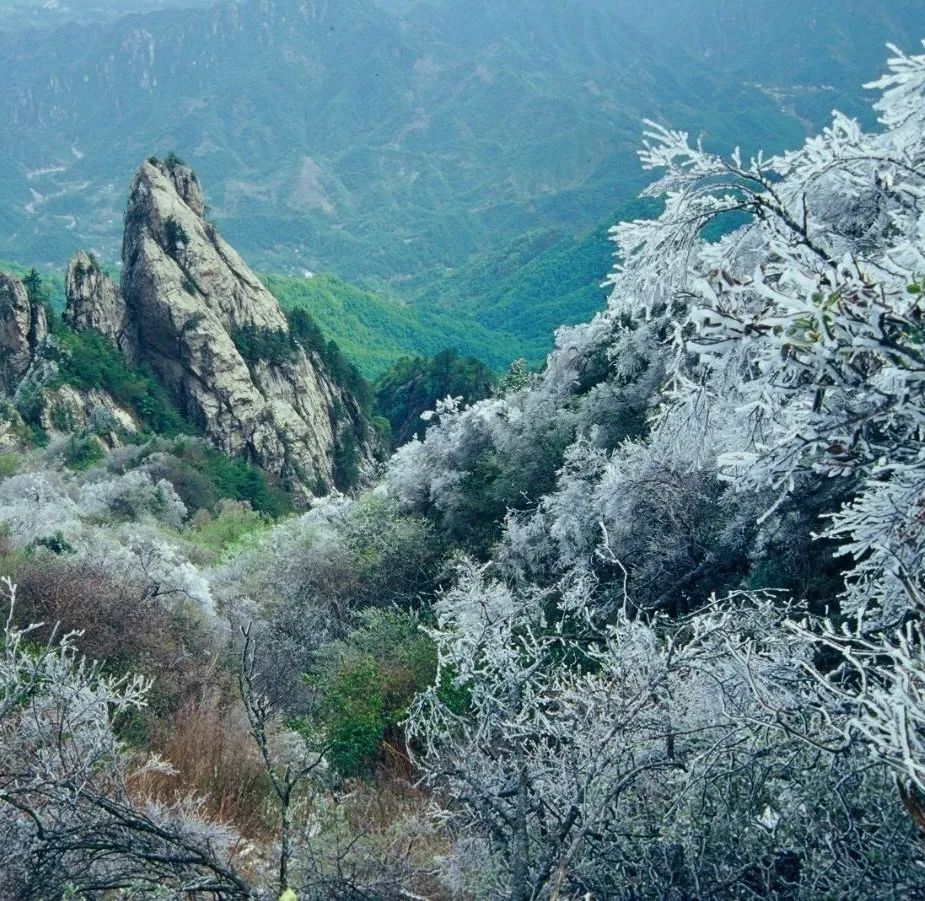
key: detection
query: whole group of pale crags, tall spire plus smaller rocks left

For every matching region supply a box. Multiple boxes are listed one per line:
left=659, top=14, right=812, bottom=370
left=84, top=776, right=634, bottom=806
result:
left=0, top=158, right=375, bottom=502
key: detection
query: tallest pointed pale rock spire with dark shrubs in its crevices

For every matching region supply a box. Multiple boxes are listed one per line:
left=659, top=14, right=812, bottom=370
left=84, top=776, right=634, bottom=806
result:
left=122, top=161, right=372, bottom=501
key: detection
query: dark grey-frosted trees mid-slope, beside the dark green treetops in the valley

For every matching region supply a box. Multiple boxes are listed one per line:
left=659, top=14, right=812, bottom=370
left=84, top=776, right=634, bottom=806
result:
left=385, top=316, right=662, bottom=556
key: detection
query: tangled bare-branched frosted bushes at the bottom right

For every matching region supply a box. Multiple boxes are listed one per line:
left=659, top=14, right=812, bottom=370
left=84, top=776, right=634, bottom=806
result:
left=409, top=565, right=917, bottom=899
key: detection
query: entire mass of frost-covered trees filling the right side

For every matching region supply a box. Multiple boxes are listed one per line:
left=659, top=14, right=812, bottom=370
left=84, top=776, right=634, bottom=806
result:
left=387, top=40, right=925, bottom=897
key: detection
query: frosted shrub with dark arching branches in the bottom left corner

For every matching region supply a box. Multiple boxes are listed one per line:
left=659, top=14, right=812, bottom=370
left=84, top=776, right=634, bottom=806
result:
left=0, top=583, right=252, bottom=898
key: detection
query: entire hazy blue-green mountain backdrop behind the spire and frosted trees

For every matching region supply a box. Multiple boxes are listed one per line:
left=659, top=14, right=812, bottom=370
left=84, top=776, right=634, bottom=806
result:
left=0, top=0, right=925, bottom=373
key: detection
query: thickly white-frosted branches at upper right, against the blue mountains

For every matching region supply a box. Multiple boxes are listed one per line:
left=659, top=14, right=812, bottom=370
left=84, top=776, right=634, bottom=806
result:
left=615, top=42, right=925, bottom=623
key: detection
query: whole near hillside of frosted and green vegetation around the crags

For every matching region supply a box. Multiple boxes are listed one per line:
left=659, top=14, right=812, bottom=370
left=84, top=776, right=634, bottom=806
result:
left=0, top=33, right=925, bottom=901
